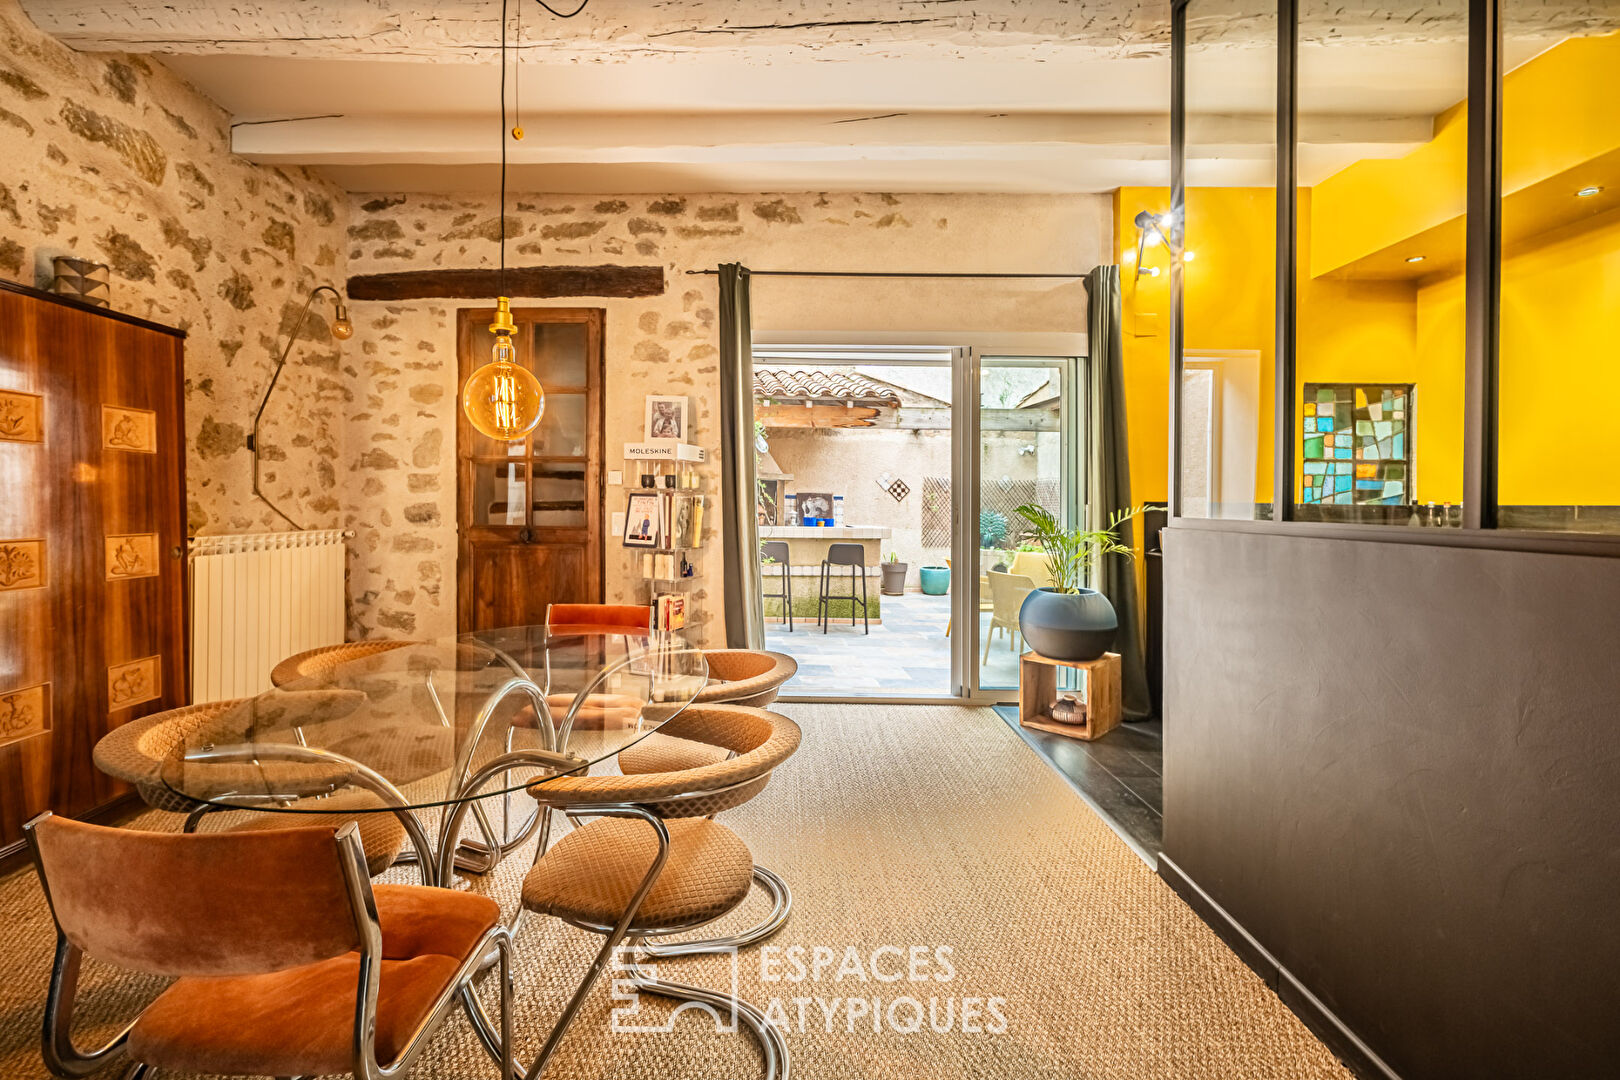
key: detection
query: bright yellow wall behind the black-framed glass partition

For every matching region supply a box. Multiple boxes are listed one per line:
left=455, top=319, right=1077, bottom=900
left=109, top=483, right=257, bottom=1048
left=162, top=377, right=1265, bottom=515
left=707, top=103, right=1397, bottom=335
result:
left=1115, top=36, right=1620, bottom=505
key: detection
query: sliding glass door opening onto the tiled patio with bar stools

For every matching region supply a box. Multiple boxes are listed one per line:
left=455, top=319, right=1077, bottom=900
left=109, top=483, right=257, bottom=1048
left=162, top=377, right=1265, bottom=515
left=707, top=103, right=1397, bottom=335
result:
left=753, top=342, right=1085, bottom=701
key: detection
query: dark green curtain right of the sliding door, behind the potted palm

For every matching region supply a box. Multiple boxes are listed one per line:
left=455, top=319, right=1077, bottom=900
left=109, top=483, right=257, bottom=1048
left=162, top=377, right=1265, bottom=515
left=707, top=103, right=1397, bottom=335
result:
left=1085, top=266, right=1153, bottom=721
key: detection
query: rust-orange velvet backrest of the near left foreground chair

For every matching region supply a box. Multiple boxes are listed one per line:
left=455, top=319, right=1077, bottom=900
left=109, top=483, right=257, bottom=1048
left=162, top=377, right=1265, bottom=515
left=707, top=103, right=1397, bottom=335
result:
left=28, top=816, right=371, bottom=976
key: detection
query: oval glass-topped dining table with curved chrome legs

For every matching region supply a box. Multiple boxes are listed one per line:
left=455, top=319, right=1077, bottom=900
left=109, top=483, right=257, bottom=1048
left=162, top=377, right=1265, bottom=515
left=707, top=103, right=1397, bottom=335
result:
left=159, top=627, right=708, bottom=884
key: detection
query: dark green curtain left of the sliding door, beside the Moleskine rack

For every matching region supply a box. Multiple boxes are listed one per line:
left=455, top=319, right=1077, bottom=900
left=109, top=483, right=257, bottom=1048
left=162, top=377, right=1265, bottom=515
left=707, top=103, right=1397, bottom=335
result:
left=719, top=262, right=765, bottom=649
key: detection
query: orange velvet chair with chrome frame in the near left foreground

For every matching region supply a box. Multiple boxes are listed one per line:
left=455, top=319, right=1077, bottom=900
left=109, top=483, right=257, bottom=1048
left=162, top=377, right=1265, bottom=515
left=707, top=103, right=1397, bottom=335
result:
left=26, top=814, right=512, bottom=1080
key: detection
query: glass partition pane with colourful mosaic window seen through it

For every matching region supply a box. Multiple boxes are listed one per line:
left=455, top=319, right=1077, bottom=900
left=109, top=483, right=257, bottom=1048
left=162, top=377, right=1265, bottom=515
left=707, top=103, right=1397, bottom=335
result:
left=1293, top=0, right=1468, bottom=528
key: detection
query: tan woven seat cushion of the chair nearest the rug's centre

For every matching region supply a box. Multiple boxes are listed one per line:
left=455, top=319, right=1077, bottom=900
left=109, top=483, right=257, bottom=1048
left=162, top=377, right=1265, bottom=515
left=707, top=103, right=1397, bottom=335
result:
left=523, top=818, right=753, bottom=933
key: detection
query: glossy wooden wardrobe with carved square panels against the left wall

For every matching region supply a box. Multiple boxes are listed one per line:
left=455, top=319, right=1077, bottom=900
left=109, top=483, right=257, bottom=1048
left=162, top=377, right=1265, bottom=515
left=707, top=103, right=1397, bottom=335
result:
left=0, top=280, right=186, bottom=857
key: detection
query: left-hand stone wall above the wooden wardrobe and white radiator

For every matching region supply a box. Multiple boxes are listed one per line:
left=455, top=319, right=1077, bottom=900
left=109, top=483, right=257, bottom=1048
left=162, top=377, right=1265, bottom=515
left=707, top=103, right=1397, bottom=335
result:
left=0, top=0, right=348, bottom=533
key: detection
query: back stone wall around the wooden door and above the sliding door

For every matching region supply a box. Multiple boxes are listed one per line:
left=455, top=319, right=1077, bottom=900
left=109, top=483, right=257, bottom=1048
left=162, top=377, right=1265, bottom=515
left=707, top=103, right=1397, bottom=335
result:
left=343, top=194, right=1111, bottom=643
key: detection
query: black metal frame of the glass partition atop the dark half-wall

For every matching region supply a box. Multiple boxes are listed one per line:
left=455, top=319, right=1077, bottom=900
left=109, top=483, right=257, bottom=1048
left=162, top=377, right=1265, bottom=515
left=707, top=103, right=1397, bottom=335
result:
left=1168, top=0, right=1620, bottom=557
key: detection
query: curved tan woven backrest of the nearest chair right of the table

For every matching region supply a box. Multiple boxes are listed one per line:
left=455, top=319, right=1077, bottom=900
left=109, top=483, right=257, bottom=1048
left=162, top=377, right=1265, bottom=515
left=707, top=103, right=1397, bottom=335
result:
left=528, top=704, right=799, bottom=814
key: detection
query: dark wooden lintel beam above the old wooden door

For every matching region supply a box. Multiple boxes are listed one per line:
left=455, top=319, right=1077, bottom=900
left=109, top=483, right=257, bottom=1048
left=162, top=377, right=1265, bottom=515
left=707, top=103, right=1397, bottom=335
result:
left=348, top=264, right=664, bottom=300
